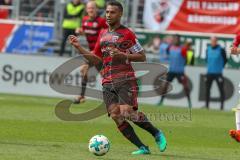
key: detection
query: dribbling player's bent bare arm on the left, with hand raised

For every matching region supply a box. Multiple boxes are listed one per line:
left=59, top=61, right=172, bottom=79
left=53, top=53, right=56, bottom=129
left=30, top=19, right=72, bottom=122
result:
left=69, top=35, right=102, bottom=65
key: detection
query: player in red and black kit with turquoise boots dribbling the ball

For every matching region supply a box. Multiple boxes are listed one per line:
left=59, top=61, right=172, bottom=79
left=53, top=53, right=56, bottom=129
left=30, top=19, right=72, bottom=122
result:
left=70, top=1, right=167, bottom=155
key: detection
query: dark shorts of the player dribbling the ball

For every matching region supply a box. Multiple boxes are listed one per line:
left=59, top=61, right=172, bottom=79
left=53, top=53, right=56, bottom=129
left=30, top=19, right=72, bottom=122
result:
left=103, top=80, right=138, bottom=110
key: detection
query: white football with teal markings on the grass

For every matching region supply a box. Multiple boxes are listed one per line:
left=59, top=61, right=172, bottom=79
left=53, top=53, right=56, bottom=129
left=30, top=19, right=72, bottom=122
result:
left=88, top=135, right=110, bottom=156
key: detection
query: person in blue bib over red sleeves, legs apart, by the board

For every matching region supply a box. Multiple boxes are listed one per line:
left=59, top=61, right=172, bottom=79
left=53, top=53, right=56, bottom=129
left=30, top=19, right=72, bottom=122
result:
left=159, top=35, right=192, bottom=108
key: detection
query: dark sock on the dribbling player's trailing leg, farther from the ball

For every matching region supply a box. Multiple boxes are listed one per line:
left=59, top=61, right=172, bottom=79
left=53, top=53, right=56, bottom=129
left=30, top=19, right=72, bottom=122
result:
left=133, top=112, right=159, bottom=137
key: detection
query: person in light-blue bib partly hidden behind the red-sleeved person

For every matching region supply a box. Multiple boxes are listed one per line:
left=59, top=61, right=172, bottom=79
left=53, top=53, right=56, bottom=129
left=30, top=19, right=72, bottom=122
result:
left=159, top=36, right=172, bottom=63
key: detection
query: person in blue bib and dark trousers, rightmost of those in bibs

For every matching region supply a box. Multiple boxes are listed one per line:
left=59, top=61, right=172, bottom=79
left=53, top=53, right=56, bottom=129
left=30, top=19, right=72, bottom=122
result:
left=206, top=37, right=227, bottom=110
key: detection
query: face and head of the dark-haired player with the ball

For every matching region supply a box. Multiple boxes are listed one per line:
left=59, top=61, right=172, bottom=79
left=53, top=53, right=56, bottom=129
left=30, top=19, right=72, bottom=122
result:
left=106, top=5, right=122, bottom=26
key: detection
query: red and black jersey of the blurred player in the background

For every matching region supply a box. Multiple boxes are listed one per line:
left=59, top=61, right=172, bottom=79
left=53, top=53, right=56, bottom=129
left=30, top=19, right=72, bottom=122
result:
left=82, top=16, right=108, bottom=51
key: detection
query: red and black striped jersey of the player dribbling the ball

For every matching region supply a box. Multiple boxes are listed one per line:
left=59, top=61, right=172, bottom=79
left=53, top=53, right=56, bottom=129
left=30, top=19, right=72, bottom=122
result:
left=93, top=26, right=143, bottom=84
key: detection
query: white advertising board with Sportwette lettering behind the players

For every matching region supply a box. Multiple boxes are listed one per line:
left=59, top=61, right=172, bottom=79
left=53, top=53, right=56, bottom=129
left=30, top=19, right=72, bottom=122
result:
left=0, top=54, right=240, bottom=110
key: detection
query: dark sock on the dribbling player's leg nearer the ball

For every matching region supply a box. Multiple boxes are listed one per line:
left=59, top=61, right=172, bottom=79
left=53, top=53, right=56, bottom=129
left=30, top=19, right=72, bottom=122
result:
left=118, top=121, right=145, bottom=148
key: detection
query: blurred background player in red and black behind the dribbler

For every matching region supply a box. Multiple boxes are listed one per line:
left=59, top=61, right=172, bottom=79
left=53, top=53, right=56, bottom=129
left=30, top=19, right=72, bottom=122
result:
left=74, top=1, right=108, bottom=104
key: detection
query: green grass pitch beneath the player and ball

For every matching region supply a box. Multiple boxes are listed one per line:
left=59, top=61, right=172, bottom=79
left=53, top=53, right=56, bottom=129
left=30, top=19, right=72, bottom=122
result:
left=0, top=94, right=240, bottom=160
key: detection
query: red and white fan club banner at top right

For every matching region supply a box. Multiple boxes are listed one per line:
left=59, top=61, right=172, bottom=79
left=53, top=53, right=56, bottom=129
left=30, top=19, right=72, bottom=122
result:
left=143, top=0, right=240, bottom=34
